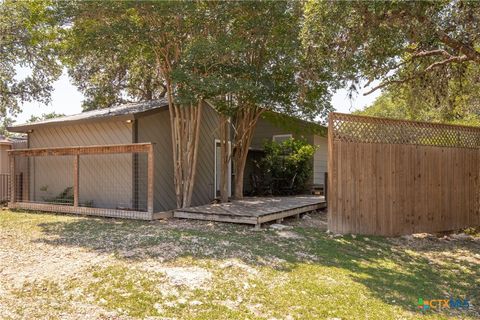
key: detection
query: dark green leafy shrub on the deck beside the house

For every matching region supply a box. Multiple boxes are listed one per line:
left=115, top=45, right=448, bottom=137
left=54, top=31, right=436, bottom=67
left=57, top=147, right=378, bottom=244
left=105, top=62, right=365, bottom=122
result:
left=257, top=138, right=315, bottom=195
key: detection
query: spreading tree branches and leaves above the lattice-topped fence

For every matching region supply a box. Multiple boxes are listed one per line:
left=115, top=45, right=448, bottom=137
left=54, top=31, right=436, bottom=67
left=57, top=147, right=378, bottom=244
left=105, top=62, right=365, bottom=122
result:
left=303, top=0, right=480, bottom=109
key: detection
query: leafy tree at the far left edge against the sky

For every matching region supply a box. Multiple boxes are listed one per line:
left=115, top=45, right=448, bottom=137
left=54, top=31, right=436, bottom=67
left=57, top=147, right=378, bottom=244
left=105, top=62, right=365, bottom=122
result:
left=0, top=0, right=62, bottom=122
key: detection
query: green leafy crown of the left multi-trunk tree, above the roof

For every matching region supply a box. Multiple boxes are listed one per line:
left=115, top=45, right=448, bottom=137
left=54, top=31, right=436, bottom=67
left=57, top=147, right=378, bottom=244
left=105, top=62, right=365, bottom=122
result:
left=58, top=1, right=227, bottom=109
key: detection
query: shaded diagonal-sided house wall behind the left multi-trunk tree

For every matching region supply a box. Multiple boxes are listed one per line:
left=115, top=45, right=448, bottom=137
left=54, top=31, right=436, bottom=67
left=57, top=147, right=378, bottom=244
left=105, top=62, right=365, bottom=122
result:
left=137, top=104, right=219, bottom=212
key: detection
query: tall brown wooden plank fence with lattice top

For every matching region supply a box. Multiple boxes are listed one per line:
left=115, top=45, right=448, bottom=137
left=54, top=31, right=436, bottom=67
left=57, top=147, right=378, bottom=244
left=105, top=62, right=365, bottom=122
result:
left=328, top=113, right=480, bottom=236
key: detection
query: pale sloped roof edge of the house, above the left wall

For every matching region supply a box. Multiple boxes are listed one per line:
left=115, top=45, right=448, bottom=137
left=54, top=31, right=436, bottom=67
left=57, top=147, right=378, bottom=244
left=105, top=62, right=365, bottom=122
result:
left=7, top=98, right=168, bottom=132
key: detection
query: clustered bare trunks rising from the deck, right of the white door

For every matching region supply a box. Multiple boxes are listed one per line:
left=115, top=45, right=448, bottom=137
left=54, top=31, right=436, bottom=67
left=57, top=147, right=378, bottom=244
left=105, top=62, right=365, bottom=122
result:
left=233, top=106, right=264, bottom=199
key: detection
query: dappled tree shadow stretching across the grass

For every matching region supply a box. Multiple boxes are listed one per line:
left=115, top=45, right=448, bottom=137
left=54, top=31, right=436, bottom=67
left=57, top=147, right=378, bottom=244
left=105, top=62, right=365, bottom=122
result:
left=33, top=214, right=480, bottom=312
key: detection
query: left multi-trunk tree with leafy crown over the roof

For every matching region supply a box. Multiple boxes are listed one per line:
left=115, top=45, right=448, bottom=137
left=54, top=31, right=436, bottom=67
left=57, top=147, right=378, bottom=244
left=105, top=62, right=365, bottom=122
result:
left=61, top=1, right=233, bottom=207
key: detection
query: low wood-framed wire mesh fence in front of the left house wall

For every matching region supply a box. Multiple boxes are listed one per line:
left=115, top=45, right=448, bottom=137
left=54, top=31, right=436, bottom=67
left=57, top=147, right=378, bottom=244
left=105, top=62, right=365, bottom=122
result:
left=8, top=143, right=154, bottom=220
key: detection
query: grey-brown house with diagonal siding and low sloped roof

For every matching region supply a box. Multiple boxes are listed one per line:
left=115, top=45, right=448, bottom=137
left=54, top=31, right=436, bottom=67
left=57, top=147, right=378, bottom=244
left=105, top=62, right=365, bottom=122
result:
left=9, top=99, right=327, bottom=219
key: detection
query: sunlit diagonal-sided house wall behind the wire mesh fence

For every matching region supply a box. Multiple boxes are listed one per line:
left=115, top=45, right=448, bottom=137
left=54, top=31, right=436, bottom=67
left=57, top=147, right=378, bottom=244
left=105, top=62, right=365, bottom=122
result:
left=29, top=121, right=133, bottom=208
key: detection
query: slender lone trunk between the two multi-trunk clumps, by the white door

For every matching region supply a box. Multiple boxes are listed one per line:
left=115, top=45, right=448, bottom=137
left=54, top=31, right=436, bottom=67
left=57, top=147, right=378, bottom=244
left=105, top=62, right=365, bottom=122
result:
left=220, top=115, right=231, bottom=203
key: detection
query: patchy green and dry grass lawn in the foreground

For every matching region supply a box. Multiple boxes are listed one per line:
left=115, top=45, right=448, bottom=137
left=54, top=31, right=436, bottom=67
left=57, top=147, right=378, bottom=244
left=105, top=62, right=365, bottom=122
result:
left=0, top=210, right=480, bottom=320
